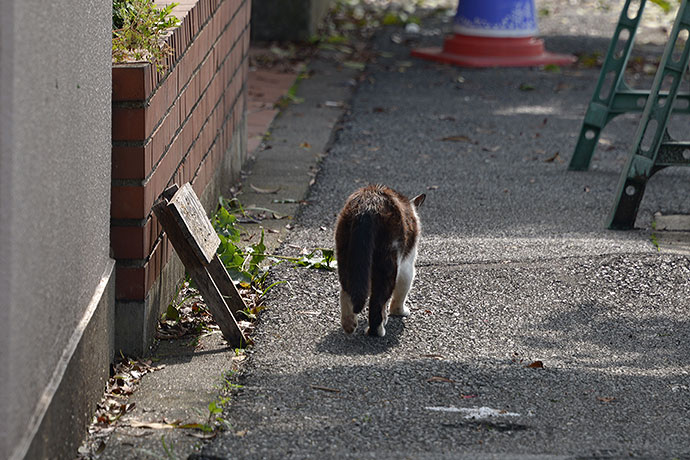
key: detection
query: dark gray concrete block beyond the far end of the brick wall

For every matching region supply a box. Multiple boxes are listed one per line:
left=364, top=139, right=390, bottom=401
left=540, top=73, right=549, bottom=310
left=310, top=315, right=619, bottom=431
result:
left=251, top=0, right=333, bottom=41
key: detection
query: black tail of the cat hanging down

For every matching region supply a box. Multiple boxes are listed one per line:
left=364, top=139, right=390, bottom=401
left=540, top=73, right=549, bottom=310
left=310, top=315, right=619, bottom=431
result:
left=347, top=214, right=376, bottom=313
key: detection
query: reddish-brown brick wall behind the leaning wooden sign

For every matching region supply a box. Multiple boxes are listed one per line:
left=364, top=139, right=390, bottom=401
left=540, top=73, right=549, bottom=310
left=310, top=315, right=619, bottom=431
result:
left=111, top=0, right=250, bottom=353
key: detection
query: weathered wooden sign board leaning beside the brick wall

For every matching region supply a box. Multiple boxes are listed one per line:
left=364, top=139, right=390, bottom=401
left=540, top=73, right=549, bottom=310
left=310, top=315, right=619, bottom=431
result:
left=153, top=183, right=247, bottom=347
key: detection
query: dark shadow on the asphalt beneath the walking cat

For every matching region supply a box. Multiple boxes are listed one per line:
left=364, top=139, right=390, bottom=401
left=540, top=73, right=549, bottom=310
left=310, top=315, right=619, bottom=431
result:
left=316, top=316, right=405, bottom=355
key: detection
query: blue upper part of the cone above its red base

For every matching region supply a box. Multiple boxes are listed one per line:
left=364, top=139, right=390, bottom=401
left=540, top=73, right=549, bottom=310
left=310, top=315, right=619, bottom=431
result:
left=453, top=0, right=538, bottom=37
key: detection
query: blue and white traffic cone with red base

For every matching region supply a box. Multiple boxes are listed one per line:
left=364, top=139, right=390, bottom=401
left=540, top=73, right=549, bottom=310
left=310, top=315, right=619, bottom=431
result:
left=411, top=0, right=576, bottom=67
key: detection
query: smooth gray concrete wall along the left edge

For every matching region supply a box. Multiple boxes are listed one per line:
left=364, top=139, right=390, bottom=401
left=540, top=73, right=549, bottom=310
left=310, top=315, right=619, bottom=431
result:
left=0, top=0, right=113, bottom=458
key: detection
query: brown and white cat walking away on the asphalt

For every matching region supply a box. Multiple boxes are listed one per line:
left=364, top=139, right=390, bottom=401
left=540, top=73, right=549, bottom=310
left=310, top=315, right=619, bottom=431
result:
left=335, top=185, right=426, bottom=337
